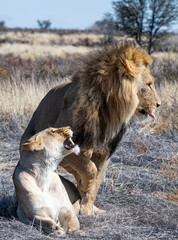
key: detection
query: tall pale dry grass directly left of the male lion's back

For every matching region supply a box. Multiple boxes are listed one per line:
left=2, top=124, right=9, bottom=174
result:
left=0, top=73, right=62, bottom=137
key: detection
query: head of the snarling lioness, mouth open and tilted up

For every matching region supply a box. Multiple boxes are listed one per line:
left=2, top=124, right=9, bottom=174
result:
left=22, top=127, right=80, bottom=158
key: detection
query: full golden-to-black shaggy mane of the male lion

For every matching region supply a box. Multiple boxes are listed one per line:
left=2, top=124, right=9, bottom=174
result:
left=73, top=41, right=151, bottom=151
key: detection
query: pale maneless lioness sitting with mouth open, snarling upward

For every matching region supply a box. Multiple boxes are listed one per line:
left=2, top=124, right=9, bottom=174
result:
left=13, top=127, right=79, bottom=234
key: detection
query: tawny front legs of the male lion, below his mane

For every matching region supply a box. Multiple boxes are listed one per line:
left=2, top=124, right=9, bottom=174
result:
left=61, top=154, right=109, bottom=215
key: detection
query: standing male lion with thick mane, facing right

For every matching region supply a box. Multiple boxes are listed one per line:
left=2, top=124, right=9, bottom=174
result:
left=21, top=41, right=160, bottom=215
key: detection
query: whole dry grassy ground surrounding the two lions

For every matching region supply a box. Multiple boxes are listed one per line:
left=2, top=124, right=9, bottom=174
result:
left=0, top=31, right=178, bottom=240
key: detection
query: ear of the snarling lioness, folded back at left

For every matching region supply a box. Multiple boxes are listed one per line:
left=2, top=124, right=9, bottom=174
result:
left=22, top=136, right=43, bottom=151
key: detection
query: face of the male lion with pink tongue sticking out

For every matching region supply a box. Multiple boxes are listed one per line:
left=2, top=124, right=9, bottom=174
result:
left=135, top=67, right=161, bottom=118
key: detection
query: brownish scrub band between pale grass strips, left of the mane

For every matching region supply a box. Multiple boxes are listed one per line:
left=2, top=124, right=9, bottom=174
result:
left=0, top=54, right=74, bottom=82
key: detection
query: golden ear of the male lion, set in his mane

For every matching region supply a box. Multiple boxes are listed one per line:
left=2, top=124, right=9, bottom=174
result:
left=116, top=57, right=141, bottom=76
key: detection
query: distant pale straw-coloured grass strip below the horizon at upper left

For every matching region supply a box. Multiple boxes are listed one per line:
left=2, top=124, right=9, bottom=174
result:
left=0, top=31, right=131, bottom=60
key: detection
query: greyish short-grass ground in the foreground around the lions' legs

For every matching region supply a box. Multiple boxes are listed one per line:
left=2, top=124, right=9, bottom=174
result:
left=0, top=122, right=178, bottom=240
